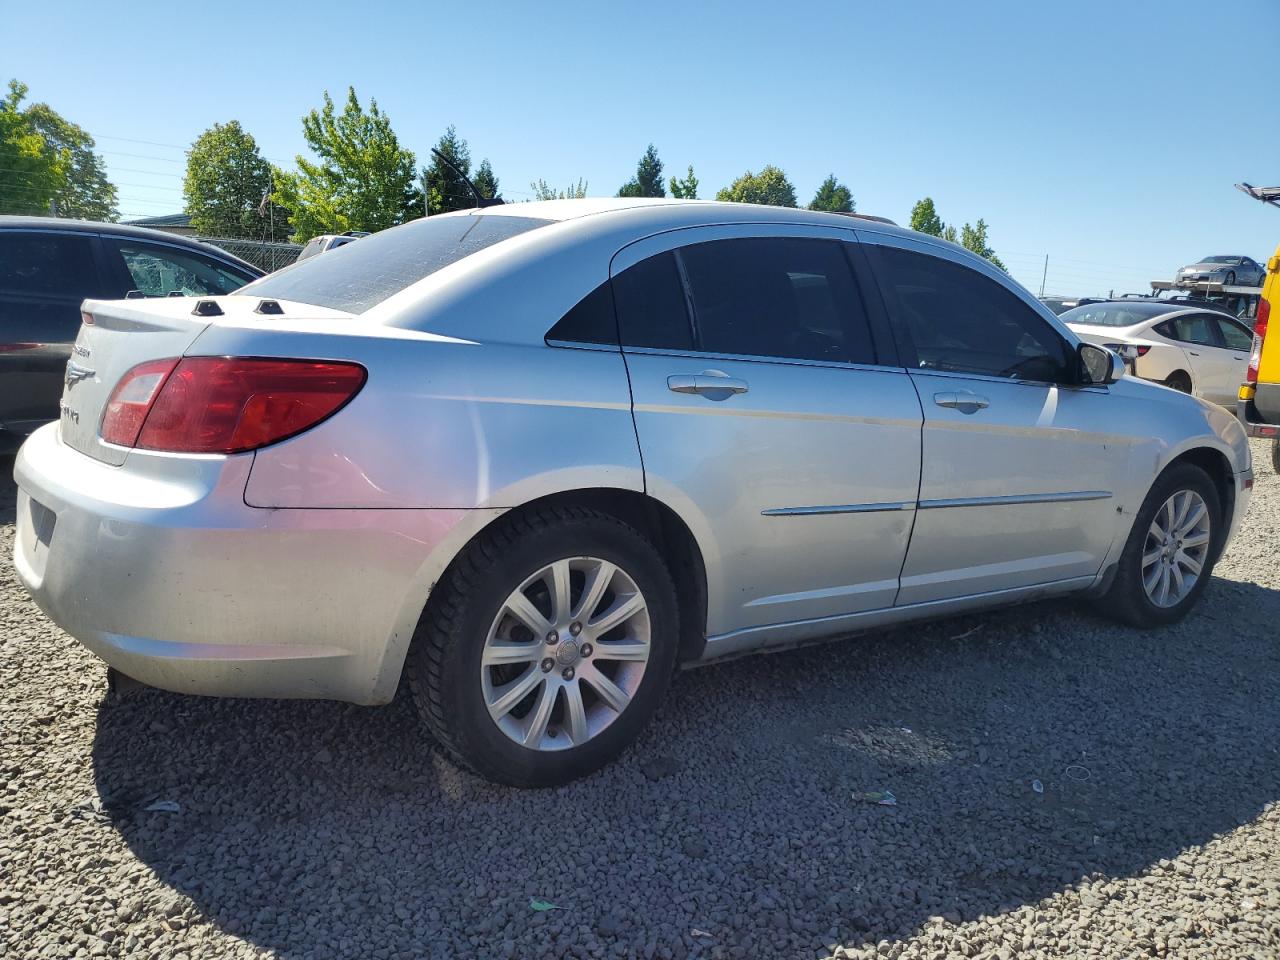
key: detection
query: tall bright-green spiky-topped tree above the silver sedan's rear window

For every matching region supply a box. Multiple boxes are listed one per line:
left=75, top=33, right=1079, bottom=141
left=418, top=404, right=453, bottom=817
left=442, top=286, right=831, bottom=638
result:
left=273, top=87, right=422, bottom=241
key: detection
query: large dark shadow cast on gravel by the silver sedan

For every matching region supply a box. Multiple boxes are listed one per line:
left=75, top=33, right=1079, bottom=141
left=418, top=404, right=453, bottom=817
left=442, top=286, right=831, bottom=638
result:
left=93, top=580, right=1280, bottom=957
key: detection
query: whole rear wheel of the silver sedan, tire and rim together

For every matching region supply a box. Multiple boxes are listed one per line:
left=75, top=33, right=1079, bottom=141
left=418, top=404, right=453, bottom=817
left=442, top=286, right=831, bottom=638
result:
left=406, top=508, right=678, bottom=787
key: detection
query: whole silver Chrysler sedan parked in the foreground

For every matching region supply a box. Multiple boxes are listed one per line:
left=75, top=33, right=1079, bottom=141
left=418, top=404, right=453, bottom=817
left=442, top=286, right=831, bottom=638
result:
left=15, top=200, right=1253, bottom=786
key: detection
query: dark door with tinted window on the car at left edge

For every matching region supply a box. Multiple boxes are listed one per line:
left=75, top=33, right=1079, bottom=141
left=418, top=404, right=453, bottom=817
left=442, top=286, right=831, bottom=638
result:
left=0, top=229, right=109, bottom=435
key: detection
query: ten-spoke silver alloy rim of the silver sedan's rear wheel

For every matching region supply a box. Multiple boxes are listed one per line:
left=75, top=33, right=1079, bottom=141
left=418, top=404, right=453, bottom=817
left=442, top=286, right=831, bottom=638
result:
left=480, top=557, right=650, bottom=750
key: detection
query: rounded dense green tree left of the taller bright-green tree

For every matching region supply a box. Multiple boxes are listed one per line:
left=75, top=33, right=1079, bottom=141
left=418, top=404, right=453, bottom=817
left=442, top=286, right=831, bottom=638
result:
left=182, top=120, right=276, bottom=238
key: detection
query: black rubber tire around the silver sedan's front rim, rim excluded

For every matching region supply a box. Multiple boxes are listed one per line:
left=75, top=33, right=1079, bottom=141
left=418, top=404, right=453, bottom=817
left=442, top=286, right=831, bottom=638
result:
left=1098, top=463, right=1226, bottom=628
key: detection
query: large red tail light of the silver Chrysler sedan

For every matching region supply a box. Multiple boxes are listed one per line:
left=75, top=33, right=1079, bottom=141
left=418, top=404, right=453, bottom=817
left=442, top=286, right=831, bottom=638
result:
left=101, top=357, right=366, bottom=453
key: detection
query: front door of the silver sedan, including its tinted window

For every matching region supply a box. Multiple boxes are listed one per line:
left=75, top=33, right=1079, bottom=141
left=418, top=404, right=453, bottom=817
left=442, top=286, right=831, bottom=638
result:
left=865, top=234, right=1128, bottom=605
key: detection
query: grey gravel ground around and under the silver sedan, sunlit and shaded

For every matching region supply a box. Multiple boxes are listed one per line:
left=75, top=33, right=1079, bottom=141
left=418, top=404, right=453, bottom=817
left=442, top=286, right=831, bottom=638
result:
left=0, top=445, right=1280, bottom=960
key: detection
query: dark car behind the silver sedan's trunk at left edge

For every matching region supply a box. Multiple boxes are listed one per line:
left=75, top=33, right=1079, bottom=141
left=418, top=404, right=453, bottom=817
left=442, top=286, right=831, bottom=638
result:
left=0, top=216, right=262, bottom=453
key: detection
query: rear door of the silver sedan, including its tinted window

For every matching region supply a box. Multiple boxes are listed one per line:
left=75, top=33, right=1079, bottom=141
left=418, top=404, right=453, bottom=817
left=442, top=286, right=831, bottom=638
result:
left=612, top=224, right=920, bottom=650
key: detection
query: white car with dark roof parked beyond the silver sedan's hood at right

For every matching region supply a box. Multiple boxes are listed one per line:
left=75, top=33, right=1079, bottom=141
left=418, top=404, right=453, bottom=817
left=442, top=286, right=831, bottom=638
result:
left=1059, top=300, right=1253, bottom=407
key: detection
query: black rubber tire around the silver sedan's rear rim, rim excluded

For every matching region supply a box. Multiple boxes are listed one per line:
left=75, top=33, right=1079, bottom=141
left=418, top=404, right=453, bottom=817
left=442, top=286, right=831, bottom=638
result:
left=404, top=507, right=680, bottom=787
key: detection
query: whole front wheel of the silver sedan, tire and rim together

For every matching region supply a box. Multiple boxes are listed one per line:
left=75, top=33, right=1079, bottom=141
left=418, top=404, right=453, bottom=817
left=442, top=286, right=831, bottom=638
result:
left=1101, top=463, right=1222, bottom=627
